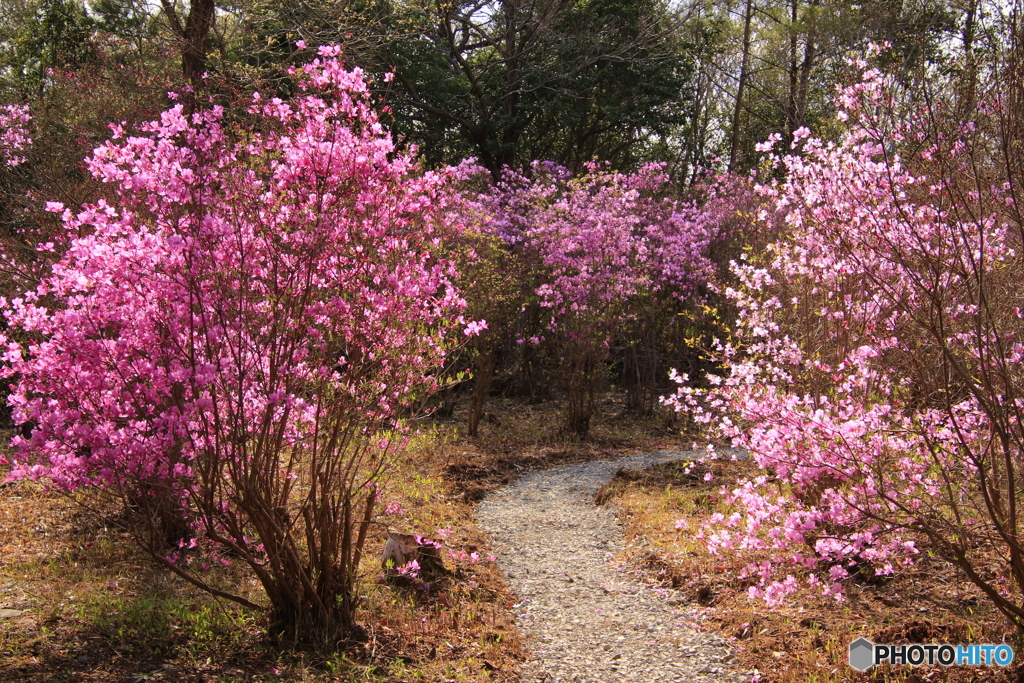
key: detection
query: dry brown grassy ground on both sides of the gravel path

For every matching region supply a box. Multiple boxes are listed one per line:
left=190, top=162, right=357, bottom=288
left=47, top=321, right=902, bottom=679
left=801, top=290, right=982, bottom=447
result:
left=9, top=395, right=1017, bottom=683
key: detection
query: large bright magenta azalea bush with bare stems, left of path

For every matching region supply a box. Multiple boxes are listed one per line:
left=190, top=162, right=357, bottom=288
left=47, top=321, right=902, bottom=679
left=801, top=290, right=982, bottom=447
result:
left=2, top=47, right=462, bottom=644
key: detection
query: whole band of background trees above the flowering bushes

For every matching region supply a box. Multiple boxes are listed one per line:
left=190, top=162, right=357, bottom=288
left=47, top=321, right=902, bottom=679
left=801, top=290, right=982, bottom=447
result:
left=0, top=0, right=1005, bottom=201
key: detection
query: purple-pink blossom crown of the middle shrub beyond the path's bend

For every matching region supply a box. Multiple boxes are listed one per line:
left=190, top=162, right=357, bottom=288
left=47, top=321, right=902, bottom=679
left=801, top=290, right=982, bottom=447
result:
left=468, top=162, right=731, bottom=325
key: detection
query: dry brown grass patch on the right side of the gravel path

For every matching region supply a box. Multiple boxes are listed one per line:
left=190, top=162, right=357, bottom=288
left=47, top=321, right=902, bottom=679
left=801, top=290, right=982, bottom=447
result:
left=598, top=462, right=1020, bottom=683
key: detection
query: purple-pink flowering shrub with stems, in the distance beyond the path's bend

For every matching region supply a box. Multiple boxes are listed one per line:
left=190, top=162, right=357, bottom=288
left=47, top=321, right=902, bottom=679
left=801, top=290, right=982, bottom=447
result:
left=464, top=162, right=735, bottom=434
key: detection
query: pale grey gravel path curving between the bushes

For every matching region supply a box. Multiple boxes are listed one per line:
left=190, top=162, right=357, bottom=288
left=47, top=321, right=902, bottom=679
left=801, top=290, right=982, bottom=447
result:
left=477, top=452, right=750, bottom=683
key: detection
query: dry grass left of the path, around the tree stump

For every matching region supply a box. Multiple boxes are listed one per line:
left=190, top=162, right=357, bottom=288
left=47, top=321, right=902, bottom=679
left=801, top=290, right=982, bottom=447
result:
left=0, top=426, right=523, bottom=683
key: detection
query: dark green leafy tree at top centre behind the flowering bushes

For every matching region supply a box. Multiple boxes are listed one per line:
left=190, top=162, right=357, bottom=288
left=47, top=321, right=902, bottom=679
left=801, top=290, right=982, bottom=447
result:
left=383, top=0, right=693, bottom=174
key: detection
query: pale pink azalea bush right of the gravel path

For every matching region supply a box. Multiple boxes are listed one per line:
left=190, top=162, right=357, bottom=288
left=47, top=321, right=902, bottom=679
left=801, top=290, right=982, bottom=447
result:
left=668, top=63, right=1024, bottom=625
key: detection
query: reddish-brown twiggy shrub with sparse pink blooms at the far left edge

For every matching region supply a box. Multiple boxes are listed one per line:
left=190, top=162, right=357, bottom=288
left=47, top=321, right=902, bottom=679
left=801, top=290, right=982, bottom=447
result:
left=0, top=38, right=180, bottom=305
